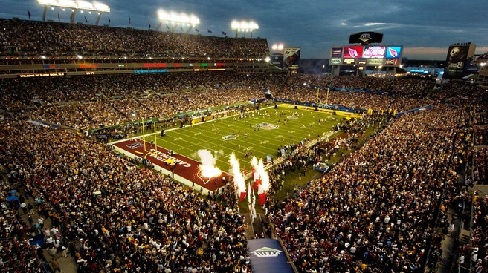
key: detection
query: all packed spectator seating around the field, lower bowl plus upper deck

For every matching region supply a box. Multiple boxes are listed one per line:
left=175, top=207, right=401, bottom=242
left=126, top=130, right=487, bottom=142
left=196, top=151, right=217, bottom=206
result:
left=0, top=20, right=487, bottom=272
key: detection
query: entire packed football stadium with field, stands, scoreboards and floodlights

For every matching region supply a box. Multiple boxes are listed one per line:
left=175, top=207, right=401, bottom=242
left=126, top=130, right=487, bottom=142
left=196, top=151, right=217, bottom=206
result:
left=0, top=0, right=488, bottom=273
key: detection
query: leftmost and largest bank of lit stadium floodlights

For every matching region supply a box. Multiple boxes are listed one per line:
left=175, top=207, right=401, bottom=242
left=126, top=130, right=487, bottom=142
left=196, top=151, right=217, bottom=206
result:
left=37, top=0, right=110, bottom=25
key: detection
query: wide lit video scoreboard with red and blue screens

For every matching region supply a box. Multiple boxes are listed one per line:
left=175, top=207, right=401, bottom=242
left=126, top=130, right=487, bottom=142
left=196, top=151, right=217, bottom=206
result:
left=329, top=45, right=403, bottom=67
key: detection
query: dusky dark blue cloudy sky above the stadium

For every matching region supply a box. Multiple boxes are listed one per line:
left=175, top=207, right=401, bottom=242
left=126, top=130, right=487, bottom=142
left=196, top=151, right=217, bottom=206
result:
left=0, top=0, right=488, bottom=60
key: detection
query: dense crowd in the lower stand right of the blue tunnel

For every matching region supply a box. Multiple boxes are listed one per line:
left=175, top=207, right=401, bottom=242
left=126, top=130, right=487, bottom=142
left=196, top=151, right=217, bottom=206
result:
left=270, top=103, right=466, bottom=272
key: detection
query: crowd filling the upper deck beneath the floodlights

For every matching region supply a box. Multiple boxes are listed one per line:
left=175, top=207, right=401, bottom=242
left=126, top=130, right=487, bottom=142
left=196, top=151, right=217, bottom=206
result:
left=0, top=19, right=269, bottom=60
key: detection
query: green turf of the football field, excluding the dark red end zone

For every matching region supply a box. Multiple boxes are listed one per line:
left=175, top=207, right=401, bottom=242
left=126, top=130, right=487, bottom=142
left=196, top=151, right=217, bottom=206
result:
left=145, top=105, right=344, bottom=171
